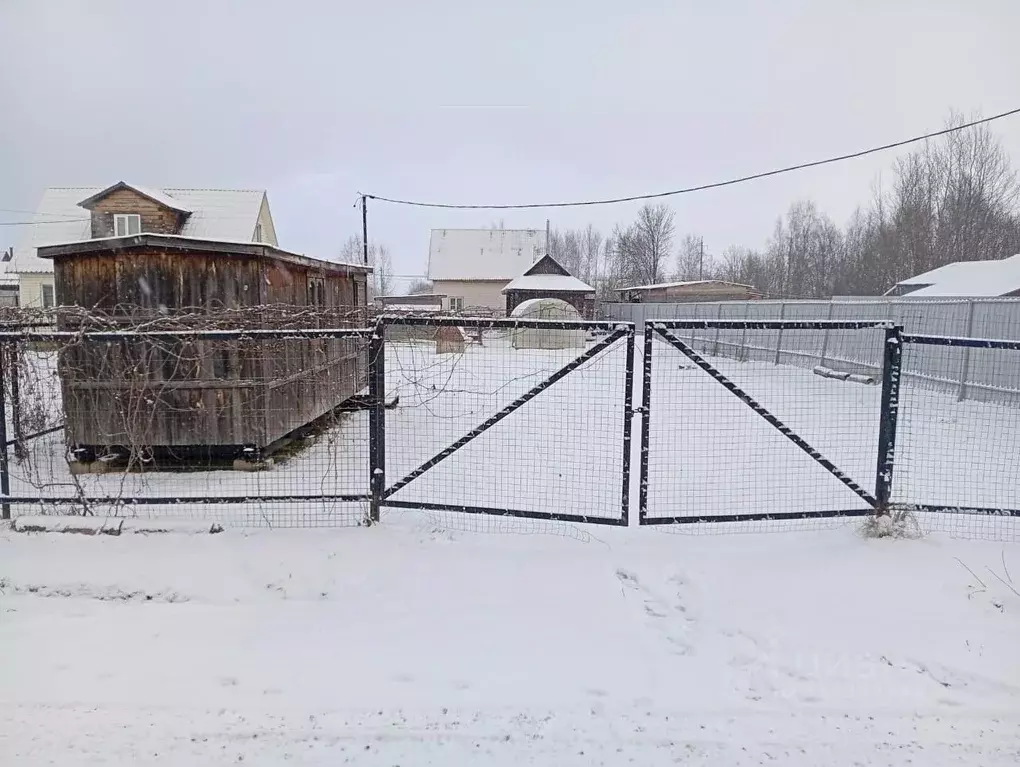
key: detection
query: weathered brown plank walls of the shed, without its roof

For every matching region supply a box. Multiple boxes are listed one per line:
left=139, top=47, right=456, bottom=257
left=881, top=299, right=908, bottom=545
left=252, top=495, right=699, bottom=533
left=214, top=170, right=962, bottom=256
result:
left=55, top=245, right=367, bottom=447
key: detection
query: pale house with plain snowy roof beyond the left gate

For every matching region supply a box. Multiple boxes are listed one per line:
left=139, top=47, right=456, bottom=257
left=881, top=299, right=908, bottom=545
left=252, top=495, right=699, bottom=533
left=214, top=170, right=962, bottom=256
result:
left=428, top=229, right=546, bottom=312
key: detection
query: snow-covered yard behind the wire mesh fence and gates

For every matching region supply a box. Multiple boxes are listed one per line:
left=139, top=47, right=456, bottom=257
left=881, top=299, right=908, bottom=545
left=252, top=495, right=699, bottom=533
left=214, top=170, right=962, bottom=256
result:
left=11, top=335, right=1020, bottom=531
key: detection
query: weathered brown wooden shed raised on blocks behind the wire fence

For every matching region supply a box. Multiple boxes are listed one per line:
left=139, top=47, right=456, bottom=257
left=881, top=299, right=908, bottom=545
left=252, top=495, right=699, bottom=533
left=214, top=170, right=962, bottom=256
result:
left=39, top=227, right=370, bottom=461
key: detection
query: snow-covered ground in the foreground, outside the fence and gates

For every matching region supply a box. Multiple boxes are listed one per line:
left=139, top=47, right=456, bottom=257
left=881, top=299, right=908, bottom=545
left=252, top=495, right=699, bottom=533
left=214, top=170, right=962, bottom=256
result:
left=0, top=512, right=1020, bottom=767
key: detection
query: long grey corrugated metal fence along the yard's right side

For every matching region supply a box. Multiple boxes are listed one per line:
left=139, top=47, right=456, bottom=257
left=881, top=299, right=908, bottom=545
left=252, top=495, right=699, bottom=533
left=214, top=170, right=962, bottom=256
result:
left=600, top=298, right=1020, bottom=405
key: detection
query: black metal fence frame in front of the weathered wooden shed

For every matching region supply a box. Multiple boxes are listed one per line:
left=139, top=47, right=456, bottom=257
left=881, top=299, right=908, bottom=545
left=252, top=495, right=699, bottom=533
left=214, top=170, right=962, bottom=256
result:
left=0, top=327, right=376, bottom=519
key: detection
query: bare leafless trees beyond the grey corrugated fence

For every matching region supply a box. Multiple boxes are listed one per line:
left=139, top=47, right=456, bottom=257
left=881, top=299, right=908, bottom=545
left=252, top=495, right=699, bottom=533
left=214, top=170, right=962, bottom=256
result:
left=549, top=114, right=1020, bottom=298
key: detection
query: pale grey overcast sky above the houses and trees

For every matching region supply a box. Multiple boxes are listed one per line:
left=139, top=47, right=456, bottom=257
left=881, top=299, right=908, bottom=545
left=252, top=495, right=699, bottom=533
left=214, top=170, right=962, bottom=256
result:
left=0, top=0, right=1020, bottom=289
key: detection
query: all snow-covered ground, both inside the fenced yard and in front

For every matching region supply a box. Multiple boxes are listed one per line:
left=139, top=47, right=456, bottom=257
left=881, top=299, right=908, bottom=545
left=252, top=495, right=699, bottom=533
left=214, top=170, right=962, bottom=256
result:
left=0, top=337, right=1020, bottom=767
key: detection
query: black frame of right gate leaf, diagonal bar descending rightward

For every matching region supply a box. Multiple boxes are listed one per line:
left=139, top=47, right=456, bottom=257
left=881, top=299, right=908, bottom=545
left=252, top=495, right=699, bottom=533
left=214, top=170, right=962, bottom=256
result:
left=639, top=319, right=902, bottom=525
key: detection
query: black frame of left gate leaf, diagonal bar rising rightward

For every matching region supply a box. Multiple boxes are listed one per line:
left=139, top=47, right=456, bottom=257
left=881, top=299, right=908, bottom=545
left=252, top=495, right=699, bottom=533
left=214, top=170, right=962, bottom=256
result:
left=369, top=316, right=634, bottom=527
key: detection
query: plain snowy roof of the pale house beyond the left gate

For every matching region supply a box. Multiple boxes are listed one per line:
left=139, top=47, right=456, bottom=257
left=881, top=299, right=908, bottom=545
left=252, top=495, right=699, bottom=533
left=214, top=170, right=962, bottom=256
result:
left=428, top=229, right=546, bottom=282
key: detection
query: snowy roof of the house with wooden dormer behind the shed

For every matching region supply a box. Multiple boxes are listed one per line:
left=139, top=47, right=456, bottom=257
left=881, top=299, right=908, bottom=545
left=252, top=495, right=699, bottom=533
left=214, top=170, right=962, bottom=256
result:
left=10, top=186, right=265, bottom=273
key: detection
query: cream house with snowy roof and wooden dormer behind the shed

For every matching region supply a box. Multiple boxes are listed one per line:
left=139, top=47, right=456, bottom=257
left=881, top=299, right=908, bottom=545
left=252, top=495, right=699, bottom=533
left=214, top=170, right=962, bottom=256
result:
left=8, top=182, right=278, bottom=308
